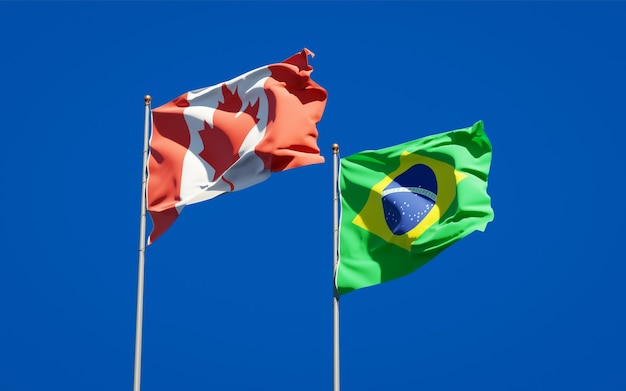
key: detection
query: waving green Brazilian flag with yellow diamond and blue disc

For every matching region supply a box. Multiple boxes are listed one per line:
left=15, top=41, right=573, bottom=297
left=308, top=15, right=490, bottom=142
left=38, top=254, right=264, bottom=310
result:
left=335, top=121, right=493, bottom=294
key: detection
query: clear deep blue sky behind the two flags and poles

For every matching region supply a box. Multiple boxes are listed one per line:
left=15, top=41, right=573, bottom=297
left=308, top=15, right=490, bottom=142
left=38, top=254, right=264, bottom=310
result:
left=0, top=1, right=626, bottom=391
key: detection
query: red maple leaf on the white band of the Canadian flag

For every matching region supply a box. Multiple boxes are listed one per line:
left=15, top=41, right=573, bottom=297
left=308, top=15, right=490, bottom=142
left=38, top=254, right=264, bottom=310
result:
left=199, top=84, right=259, bottom=181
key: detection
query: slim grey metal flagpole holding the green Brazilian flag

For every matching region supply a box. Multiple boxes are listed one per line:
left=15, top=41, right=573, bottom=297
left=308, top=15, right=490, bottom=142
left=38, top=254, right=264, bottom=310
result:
left=333, top=144, right=340, bottom=391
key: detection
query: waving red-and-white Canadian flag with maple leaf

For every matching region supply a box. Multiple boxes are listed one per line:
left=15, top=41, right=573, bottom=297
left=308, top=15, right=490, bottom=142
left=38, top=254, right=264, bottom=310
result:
left=147, top=49, right=328, bottom=244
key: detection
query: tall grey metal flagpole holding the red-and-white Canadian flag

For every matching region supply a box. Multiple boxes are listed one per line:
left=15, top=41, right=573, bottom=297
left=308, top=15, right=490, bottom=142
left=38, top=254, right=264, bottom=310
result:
left=133, top=95, right=152, bottom=391
